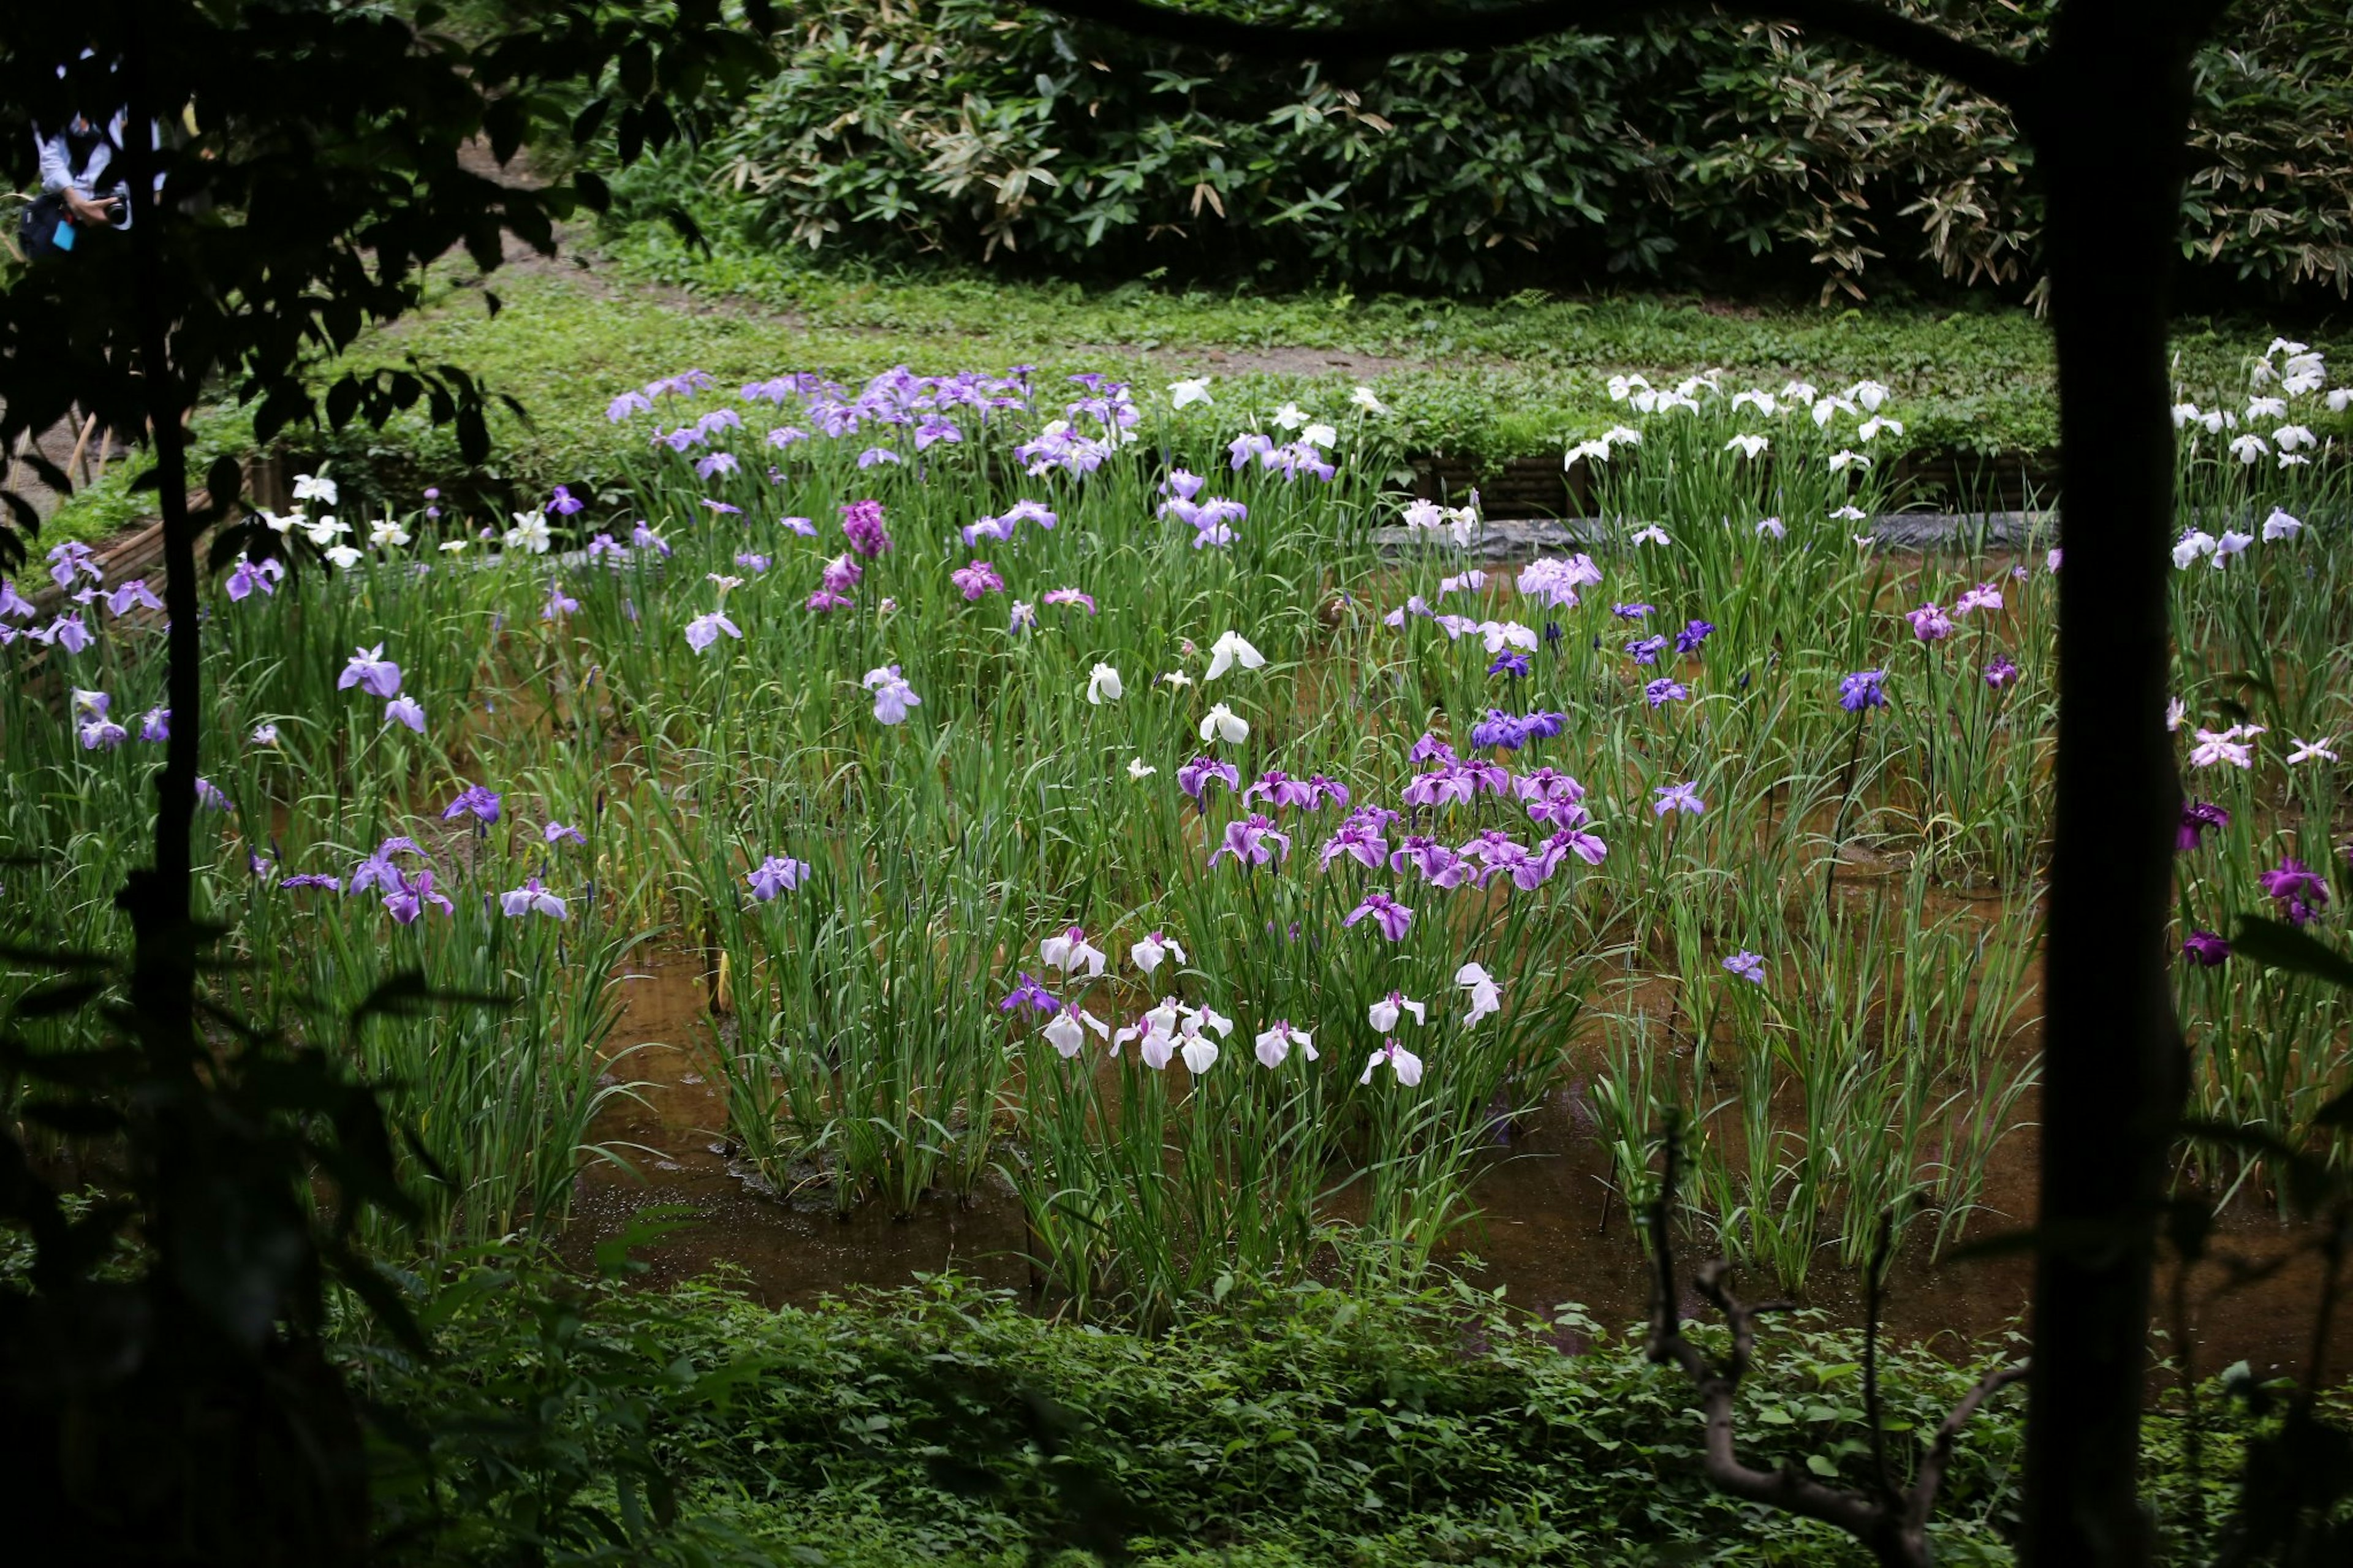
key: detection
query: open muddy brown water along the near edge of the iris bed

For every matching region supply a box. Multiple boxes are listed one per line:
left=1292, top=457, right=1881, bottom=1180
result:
left=565, top=953, right=2353, bottom=1377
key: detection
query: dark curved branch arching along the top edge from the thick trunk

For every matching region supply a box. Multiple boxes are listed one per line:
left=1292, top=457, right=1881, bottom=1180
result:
left=1040, top=0, right=2036, bottom=113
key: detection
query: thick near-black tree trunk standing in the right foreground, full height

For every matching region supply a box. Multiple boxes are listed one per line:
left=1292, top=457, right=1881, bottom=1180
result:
left=2023, top=0, right=2191, bottom=1568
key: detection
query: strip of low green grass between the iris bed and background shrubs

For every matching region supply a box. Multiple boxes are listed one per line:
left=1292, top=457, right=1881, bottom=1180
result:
left=45, top=229, right=2353, bottom=539
